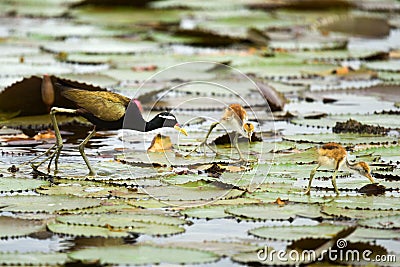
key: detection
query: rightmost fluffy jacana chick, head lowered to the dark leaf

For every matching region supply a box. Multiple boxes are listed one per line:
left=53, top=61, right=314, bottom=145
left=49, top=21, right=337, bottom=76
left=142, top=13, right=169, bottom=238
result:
left=305, top=143, right=375, bottom=195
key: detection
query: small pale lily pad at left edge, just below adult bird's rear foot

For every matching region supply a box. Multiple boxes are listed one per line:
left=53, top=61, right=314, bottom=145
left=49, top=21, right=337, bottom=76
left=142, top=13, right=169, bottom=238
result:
left=0, top=177, right=49, bottom=193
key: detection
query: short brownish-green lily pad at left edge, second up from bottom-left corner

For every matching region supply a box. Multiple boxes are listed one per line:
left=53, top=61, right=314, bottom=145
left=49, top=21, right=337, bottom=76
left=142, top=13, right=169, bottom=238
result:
left=0, top=216, right=45, bottom=240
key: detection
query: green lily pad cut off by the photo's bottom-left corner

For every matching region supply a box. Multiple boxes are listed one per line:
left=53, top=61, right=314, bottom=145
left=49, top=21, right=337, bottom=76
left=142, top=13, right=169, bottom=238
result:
left=0, top=252, right=69, bottom=266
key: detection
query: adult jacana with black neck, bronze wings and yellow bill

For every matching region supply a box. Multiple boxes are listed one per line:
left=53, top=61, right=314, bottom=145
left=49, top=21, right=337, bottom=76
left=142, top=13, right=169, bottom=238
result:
left=34, top=83, right=187, bottom=175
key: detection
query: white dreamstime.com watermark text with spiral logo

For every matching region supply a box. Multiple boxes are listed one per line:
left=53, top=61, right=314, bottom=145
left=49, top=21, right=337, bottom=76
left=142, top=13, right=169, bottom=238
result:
left=257, top=239, right=397, bottom=263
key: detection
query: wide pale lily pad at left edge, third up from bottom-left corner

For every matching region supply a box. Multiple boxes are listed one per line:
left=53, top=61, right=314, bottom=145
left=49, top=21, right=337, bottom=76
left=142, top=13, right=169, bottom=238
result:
left=0, top=196, right=101, bottom=213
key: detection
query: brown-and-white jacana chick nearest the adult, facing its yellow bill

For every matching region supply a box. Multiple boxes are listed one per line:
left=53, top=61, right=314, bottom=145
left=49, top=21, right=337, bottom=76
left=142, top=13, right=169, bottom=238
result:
left=186, top=104, right=254, bottom=160
